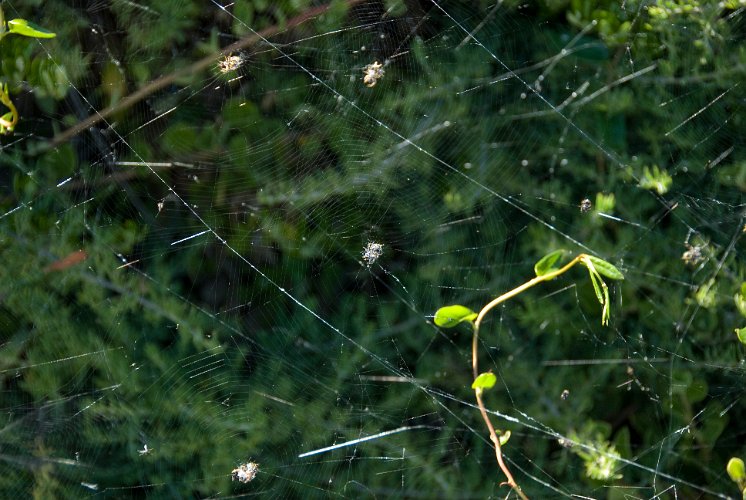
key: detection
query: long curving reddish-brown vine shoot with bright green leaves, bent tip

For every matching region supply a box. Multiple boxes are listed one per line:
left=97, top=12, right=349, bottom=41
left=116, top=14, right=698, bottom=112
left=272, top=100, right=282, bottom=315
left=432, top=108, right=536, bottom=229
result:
left=434, top=250, right=624, bottom=500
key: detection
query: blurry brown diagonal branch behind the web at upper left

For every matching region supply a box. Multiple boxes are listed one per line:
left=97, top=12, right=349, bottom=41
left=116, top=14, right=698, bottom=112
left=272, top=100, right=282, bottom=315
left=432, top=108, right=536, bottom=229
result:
left=44, top=0, right=363, bottom=149
